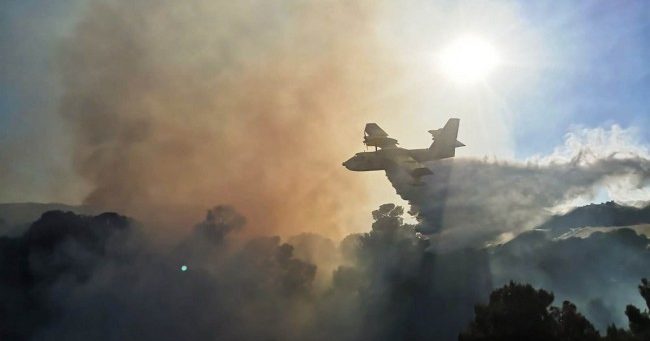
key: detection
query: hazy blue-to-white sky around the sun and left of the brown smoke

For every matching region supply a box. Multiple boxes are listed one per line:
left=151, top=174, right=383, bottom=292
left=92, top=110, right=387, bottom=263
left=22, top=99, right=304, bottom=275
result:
left=0, top=0, right=650, bottom=210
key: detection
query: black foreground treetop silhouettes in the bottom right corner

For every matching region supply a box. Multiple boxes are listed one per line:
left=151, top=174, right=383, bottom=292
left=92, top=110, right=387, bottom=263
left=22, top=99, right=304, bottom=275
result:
left=458, top=278, right=650, bottom=341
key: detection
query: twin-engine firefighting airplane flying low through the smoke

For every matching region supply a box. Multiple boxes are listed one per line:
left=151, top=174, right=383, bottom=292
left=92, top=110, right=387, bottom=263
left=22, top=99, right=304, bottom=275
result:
left=343, top=118, right=465, bottom=185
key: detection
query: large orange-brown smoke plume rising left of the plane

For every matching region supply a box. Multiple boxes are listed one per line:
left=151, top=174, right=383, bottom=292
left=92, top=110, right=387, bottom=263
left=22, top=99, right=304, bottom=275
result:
left=60, top=0, right=388, bottom=236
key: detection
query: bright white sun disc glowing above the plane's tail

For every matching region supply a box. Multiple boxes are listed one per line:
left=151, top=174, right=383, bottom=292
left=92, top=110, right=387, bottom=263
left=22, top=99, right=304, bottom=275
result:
left=438, top=36, right=499, bottom=84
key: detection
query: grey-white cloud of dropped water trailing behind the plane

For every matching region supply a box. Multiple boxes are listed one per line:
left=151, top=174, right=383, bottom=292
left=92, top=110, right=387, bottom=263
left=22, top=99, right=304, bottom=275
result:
left=387, top=127, right=650, bottom=249
